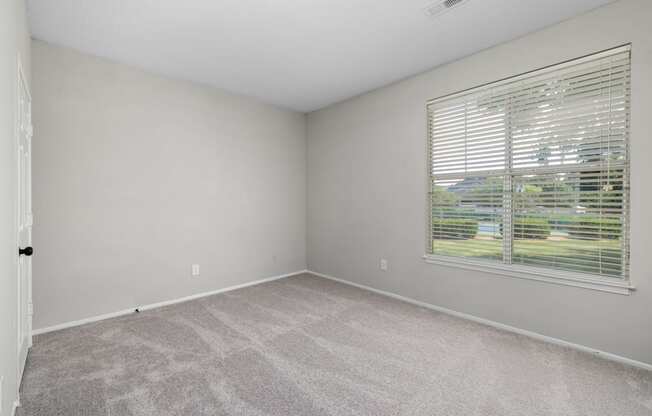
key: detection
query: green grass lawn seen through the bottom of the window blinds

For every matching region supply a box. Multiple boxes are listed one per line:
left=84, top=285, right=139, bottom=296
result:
left=432, top=238, right=622, bottom=277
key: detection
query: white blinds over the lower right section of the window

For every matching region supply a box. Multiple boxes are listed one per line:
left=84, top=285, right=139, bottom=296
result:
left=512, top=170, right=627, bottom=277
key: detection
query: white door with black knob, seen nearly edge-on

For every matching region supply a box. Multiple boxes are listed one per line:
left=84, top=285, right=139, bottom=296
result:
left=16, top=61, right=32, bottom=385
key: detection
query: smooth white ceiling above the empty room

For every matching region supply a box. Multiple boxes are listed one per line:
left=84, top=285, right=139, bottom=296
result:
left=28, top=0, right=611, bottom=112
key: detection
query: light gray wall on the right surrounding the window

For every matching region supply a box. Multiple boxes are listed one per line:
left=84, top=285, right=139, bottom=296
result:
left=308, top=0, right=652, bottom=363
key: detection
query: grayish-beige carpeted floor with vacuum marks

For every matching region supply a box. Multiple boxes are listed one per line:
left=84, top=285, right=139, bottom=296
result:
left=18, top=275, right=652, bottom=416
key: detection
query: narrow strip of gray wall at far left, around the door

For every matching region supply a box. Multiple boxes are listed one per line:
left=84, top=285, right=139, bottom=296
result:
left=0, top=0, right=30, bottom=415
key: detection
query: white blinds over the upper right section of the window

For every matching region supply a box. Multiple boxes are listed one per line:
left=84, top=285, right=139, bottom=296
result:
left=510, top=50, right=630, bottom=171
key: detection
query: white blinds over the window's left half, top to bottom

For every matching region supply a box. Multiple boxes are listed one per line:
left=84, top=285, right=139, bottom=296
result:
left=428, top=77, right=508, bottom=261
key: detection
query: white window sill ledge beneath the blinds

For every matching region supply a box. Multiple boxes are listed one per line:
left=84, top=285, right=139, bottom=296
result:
left=423, top=255, right=636, bottom=295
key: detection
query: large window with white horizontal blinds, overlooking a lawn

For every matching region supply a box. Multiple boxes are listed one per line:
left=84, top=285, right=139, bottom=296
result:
left=426, top=46, right=630, bottom=288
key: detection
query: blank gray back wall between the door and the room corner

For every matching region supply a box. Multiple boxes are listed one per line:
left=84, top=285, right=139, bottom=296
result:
left=33, top=41, right=306, bottom=329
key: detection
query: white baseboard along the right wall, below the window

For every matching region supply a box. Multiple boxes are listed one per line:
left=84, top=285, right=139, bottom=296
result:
left=308, top=270, right=652, bottom=371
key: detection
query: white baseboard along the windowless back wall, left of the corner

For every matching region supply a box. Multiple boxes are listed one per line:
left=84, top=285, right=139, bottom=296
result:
left=32, top=270, right=308, bottom=336
